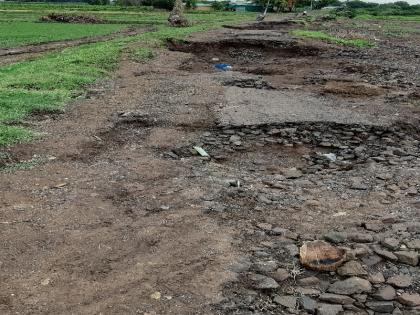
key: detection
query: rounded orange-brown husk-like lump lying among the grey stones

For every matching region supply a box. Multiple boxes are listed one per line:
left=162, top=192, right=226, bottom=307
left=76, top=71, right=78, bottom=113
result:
left=300, top=240, right=346, bottom=271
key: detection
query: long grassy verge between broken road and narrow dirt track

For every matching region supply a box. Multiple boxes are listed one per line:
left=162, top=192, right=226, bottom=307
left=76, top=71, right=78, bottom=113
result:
left=0, top=12, right=254, bottom=146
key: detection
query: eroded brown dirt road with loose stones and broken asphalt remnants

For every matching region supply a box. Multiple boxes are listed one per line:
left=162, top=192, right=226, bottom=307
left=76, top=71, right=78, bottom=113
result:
left=0, top=22, right=420, bottom=315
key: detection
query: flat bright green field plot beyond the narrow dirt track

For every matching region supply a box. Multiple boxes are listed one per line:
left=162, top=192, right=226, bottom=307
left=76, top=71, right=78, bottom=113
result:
left=0, top=22, right=124, bottom=48
